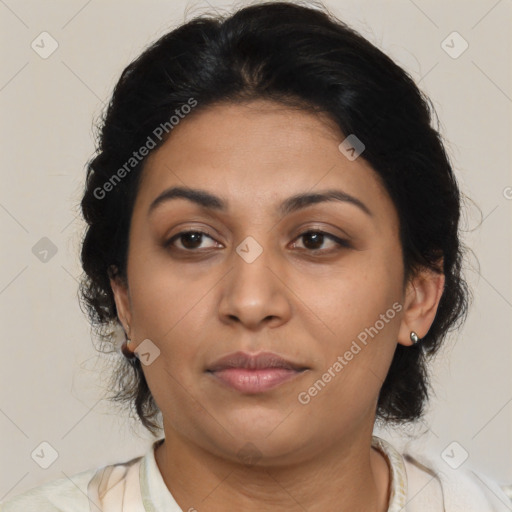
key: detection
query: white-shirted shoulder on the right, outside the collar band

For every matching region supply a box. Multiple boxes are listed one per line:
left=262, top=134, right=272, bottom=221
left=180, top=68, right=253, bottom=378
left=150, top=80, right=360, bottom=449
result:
left=403, top=453, right=512, bottom=512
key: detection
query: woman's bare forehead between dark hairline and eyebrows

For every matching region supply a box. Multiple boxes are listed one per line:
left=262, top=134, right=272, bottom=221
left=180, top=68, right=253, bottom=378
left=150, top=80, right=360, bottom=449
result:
left=137, top=100, right=393, bottom=221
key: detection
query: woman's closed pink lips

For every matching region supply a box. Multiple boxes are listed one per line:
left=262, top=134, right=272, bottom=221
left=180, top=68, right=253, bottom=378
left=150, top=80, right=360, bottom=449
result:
left=207, top=352, right=307, bottom=394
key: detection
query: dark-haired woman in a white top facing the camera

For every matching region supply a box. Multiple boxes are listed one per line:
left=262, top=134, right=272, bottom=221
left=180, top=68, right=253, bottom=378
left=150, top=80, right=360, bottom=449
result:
left=1, top=2, right=511, bottom=512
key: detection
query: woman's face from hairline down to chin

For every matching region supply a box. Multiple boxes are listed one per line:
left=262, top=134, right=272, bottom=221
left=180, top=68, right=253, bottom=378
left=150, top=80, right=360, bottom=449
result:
left=112, top=101, right=440, bottom=463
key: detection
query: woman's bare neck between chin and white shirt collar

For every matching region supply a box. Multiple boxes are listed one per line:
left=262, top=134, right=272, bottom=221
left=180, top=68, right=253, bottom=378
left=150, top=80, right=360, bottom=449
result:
left=155, top=432, right=389, bottom=512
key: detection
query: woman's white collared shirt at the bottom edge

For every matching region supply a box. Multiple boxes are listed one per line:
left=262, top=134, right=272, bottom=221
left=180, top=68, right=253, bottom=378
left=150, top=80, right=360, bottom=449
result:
left=0, top=436, right=512, bottom=512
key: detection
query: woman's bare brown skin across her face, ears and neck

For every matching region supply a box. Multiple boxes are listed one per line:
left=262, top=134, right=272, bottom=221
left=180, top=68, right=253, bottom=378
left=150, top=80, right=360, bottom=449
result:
left=111, top=100, right=444, bottom=512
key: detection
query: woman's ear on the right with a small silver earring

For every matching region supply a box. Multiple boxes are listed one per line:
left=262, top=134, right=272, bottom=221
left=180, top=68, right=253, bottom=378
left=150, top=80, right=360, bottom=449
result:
left=398, top=266, right=445, bottom=345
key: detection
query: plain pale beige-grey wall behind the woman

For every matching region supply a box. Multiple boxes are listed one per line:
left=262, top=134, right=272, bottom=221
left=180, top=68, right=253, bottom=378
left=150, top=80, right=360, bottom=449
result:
left=0, top=0, right=512, bottom=500
